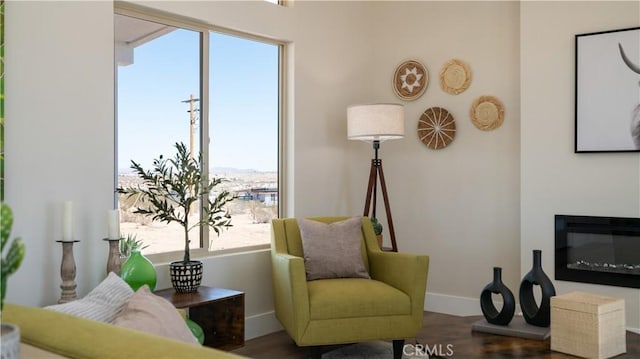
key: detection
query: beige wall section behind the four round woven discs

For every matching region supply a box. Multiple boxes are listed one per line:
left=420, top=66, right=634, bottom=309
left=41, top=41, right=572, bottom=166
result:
left=362, top=2, right=520, bottom=314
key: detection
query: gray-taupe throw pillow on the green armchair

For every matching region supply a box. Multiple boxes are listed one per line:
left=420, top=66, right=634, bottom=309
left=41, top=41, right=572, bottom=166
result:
left=298, top=217, right=370, bottom=280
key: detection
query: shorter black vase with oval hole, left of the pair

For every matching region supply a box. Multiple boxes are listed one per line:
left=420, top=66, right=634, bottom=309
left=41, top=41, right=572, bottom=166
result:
left=480, top=267, right=516, bottom=325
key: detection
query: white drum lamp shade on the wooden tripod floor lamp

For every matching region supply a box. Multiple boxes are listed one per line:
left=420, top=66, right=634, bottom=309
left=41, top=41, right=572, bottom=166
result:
left=347, top=103, right=404, bottom=141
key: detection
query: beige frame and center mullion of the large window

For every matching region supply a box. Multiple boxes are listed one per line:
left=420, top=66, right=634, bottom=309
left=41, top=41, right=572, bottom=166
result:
left=113, top=2, right=289, bottom=263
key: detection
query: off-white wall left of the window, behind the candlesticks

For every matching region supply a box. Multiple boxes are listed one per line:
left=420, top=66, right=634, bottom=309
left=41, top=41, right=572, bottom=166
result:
left=5, top=1, right=114, bottom=305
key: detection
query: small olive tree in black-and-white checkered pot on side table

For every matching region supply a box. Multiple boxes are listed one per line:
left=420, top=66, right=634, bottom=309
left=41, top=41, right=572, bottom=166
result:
left=116, top=143, right=233, bottom=293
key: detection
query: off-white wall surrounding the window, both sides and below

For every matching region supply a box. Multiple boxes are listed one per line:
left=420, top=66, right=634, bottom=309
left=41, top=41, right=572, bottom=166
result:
left=5, top=1, right=371, bottom=338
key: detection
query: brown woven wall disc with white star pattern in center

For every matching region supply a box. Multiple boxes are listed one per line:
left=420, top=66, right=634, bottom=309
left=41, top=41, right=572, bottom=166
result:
left=393, top=60, right=429, bottom=101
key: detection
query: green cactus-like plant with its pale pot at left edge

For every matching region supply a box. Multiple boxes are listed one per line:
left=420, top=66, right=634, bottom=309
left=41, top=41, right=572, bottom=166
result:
left=0, top=202, right=25, bottom=359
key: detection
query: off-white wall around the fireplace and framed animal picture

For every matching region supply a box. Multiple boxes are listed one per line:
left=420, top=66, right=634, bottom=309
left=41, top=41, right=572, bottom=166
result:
left=520, top=1, right=640, bottom=329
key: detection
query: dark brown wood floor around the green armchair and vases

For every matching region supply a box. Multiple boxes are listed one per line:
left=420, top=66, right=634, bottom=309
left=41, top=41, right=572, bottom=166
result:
left=233, top=312, right=640, bottom=359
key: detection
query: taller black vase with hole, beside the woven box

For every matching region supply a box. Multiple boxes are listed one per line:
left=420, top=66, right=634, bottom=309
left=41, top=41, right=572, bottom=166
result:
left=520, top=249, right=556, bottom=327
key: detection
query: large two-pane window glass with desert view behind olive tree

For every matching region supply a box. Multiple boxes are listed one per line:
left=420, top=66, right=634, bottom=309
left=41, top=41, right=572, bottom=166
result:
left=115, top=14, right=281, bottom=254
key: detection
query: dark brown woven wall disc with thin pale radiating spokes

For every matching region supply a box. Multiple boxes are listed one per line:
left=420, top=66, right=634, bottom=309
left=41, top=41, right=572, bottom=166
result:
left=418, top=107, right=456, bottom=150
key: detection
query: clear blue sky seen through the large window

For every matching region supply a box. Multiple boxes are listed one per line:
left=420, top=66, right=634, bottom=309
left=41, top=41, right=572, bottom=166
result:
left=118, top=29, right=278, bottom=171
